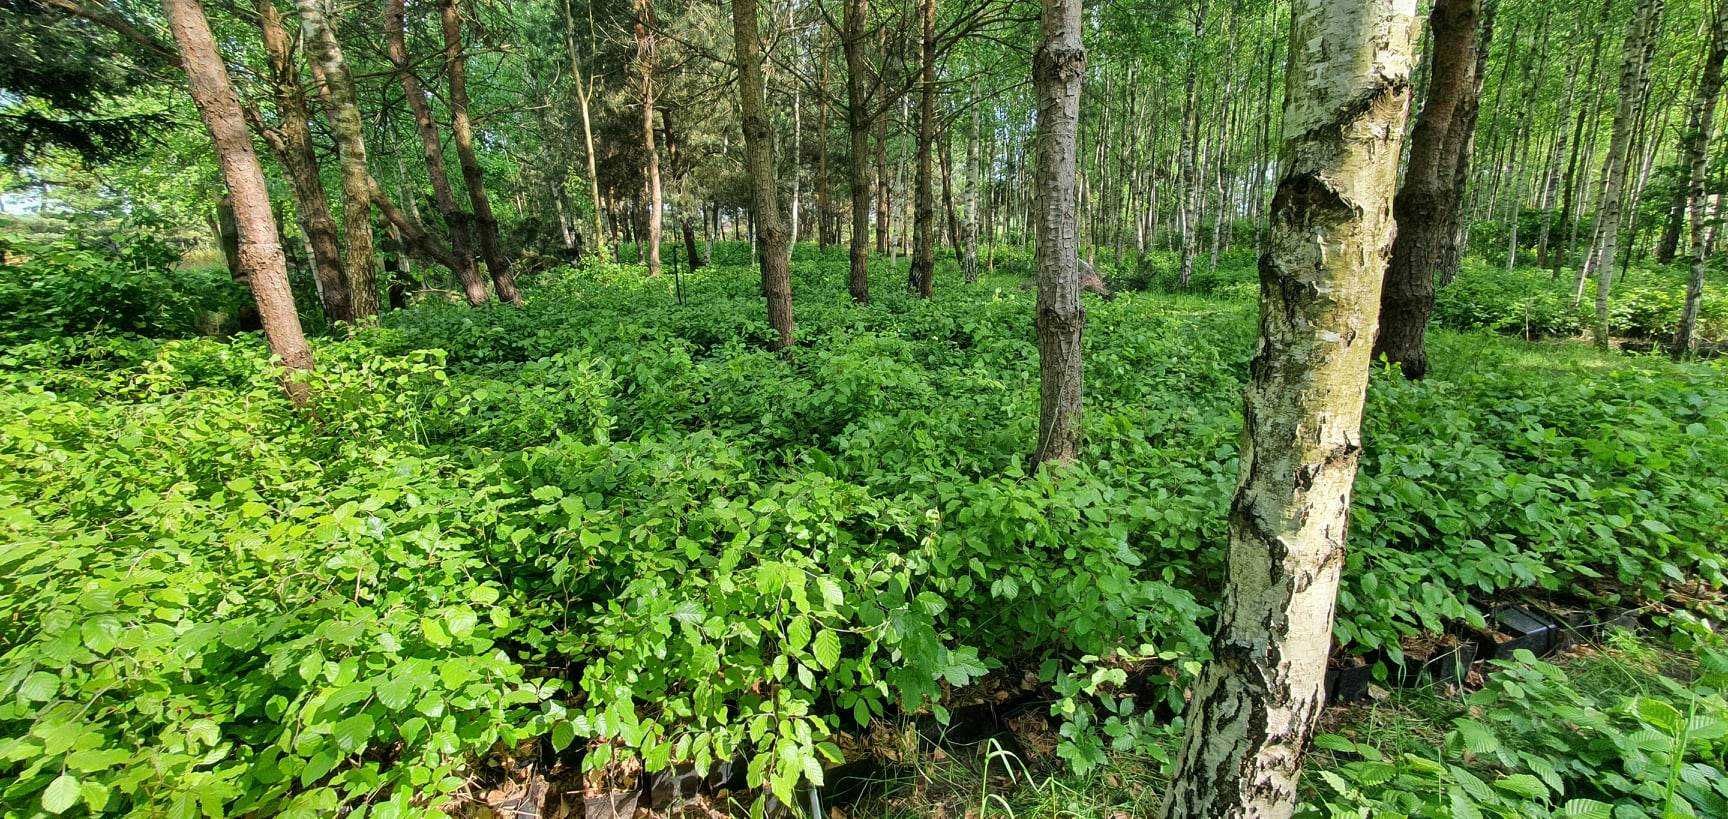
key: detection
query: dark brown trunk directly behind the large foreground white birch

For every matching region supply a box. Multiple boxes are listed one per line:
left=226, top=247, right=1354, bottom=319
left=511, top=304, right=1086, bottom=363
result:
left=1374, top=0, right=1481, bottom=378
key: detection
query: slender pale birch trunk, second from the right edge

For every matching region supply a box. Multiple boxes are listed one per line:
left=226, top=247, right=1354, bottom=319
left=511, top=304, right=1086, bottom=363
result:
left=1572, top=0, right=1662, bottom=349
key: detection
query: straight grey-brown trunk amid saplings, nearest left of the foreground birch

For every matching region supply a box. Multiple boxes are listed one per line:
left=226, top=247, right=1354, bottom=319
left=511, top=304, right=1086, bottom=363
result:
left=1032, top=0, right=1085, bottom=465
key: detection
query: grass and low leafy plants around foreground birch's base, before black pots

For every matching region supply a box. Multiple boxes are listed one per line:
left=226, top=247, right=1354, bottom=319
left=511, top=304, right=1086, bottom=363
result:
left=850, top=631, right=1728, bottom=819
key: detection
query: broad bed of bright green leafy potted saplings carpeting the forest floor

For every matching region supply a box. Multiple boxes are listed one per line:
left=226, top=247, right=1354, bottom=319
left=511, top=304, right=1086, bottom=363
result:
left=0, top=247, right=1728, bottom=816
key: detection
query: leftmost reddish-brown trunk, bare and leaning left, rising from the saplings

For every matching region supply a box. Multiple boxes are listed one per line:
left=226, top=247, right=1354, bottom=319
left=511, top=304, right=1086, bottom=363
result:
left=162, top=0, right=316, bottom=406
